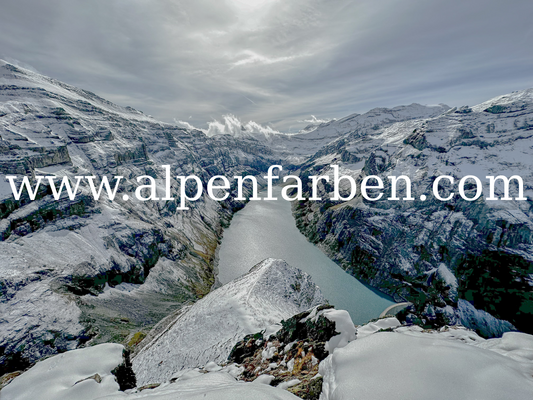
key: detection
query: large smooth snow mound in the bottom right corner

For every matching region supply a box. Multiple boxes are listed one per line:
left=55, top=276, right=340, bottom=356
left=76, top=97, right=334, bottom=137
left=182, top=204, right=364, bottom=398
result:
left=320, top=332, right=533, bottom=400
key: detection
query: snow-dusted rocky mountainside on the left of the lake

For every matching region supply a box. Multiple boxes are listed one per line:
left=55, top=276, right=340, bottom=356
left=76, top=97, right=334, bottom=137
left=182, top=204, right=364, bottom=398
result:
left=0, top=62, right=276, bottom=371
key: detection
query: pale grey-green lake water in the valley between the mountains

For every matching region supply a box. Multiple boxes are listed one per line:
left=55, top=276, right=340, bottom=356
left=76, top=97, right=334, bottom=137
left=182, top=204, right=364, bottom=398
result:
left=218, top=187, right=394, bottom=324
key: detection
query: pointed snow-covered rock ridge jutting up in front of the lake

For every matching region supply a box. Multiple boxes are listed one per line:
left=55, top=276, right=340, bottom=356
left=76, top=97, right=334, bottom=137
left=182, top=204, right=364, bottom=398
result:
left=133, top=259, right=326, bottom=385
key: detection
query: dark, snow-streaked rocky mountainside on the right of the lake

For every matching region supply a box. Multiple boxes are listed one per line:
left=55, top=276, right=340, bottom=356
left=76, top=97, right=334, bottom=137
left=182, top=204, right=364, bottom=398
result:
left=294, top=90, right=533, bottom=336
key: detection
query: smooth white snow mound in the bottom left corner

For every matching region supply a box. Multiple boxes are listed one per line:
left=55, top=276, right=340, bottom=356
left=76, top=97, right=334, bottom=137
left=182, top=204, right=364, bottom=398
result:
left=2, top=343, right=124, bottom=400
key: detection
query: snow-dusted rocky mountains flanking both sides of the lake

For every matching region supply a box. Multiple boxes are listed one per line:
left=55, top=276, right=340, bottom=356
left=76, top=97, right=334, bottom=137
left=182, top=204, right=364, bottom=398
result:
left=0, top=58, right=533, bottom=372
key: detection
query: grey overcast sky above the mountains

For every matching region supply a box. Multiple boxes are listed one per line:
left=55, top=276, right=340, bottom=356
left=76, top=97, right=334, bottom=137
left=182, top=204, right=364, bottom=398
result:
left=0, top=0, right=533, bottom=131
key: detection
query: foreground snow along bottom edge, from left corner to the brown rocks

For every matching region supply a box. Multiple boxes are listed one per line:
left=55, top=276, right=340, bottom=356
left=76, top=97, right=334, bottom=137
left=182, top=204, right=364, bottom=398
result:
left=2, top=344, right=297, bottom=400
